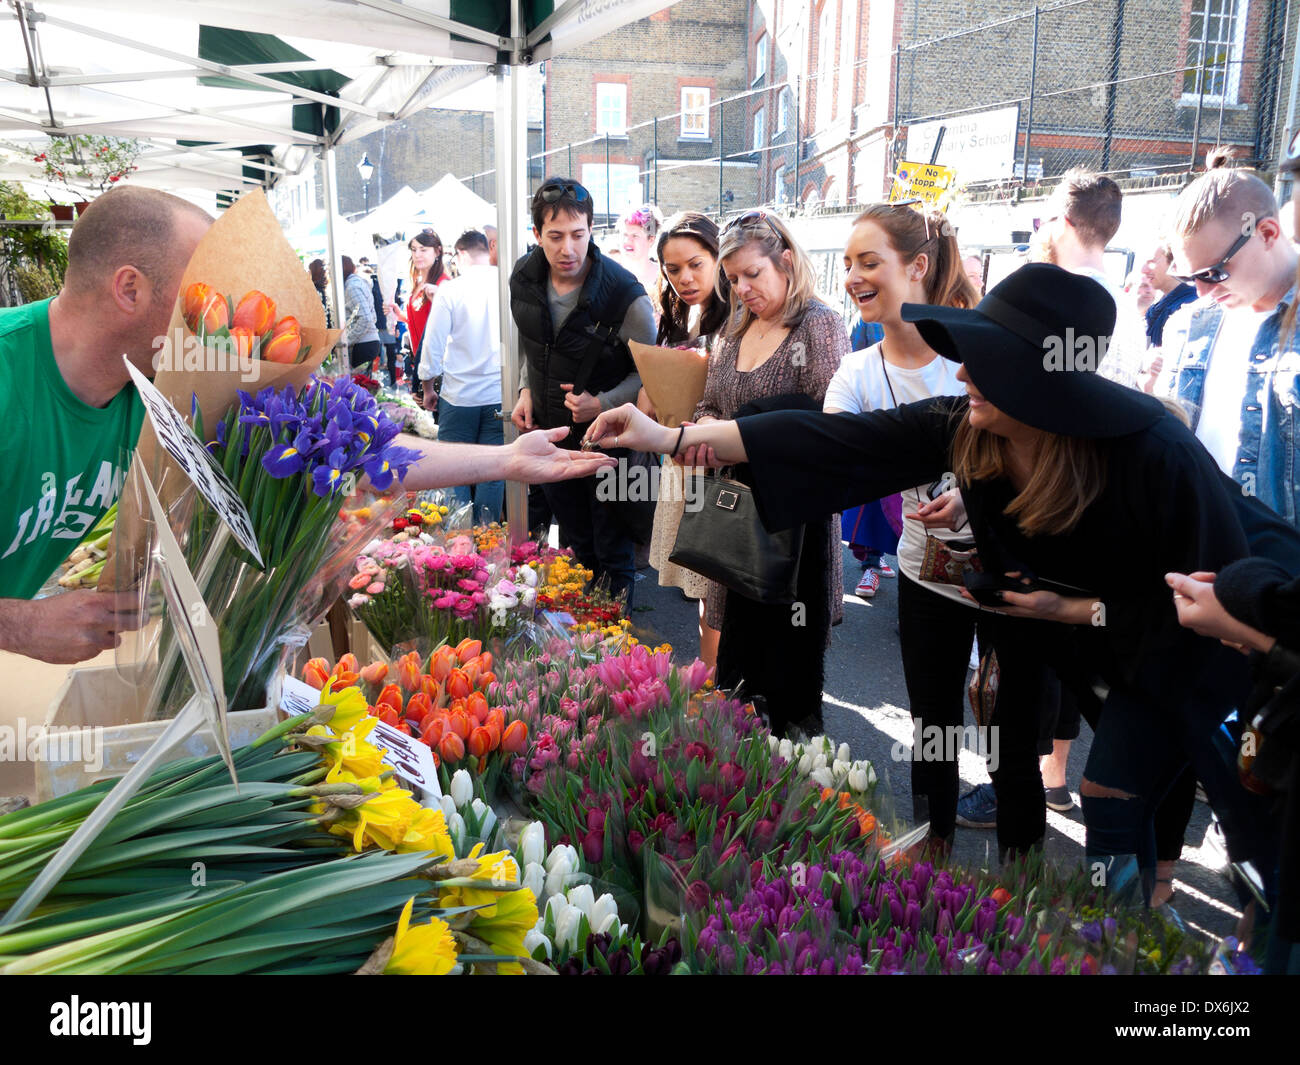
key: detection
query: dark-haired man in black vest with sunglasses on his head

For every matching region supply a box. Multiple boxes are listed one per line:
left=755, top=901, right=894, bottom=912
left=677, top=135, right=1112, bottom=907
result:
left=510, top=178, right=655, bottom=609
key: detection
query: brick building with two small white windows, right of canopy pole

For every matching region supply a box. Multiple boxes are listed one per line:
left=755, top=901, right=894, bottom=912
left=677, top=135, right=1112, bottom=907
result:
left=543, top=0, right=759, bottom=226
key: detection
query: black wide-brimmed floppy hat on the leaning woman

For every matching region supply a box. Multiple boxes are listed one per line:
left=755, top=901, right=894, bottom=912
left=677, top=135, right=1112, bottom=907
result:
left=902, top=263, right=1165, bottom=438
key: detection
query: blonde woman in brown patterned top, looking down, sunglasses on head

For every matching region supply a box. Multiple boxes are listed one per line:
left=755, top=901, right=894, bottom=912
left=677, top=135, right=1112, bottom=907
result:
left=685, top=211, right=849, bottom=735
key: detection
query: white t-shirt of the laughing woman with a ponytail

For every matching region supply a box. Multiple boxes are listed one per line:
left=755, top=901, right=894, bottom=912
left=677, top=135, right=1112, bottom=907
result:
left=823, top=343, right=971, bottom=605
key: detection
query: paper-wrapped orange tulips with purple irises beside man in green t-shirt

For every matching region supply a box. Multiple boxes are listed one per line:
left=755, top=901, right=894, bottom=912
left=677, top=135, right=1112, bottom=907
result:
left=112, top=194, right=417, bottom=718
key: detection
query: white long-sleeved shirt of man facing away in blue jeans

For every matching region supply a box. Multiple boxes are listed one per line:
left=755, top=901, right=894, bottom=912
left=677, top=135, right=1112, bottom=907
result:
left=420, top=264, right=501, bottom=407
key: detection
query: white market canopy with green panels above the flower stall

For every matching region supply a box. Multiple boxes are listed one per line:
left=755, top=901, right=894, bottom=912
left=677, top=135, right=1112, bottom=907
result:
left=0, top=0, right=672, bottom=192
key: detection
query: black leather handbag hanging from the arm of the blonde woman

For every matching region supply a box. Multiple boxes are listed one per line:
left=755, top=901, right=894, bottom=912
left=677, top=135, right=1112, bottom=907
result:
left=668, top=473, right=803, bottom=603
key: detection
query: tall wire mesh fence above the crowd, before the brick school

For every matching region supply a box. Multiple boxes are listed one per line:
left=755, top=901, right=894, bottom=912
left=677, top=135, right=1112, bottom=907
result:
left=462, top=0, right=1300, bottom=228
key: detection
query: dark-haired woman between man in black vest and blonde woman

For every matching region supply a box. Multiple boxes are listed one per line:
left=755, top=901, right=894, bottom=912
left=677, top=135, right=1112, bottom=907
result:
left=638, top=211, right=731, bottom=666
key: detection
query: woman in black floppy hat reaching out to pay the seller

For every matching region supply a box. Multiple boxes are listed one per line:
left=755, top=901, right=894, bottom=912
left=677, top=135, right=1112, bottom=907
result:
left=588, top=264, right=1300, bottom=899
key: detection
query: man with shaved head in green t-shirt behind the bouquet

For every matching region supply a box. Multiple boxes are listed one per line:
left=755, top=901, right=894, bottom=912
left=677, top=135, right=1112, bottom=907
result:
left=0, top=187, right=212, bottom=663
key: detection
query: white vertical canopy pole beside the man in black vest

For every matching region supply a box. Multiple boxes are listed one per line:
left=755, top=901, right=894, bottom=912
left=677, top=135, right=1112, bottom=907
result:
left=493, top=0, right=528, bottom=544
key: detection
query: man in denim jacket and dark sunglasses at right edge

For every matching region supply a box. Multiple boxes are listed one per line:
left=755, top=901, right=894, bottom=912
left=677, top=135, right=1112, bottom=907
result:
left=1157, top=153, right=1300, bottom=525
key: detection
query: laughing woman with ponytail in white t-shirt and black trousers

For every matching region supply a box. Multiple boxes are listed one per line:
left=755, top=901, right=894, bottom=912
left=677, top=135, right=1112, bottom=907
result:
left=824, top=203, right=979, bottom=850
